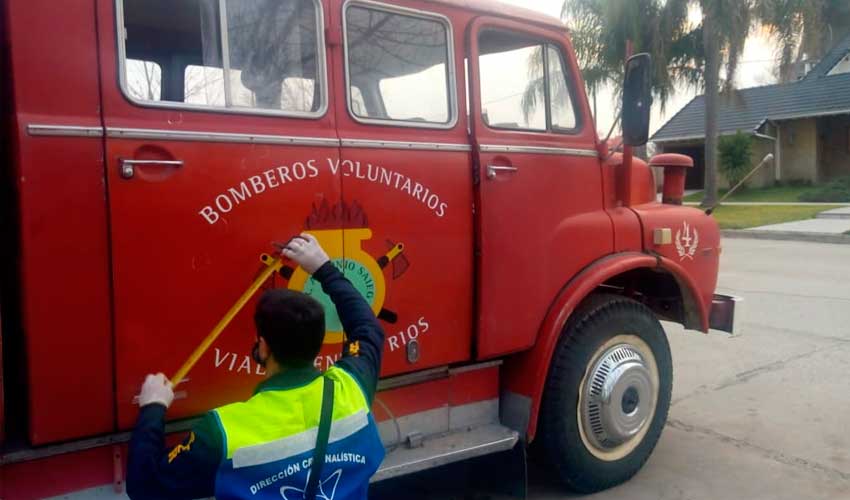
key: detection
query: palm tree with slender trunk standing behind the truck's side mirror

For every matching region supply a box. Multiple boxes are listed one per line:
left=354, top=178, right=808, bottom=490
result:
left=562, top=0, right=755, bottom=205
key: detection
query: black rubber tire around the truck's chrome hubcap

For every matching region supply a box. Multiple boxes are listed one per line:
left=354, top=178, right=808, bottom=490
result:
left=537, top=295, right=673, bottom=493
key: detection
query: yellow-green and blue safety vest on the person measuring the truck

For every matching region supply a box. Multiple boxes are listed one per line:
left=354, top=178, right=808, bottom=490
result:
left=213, top=367, right=384, bottom=500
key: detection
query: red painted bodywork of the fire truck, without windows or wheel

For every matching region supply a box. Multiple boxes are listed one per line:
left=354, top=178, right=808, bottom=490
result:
left=0, top=0, right=720, bottom=498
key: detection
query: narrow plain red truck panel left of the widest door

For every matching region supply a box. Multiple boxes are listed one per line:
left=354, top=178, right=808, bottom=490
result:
left=4, top=0, right=114, bottom=444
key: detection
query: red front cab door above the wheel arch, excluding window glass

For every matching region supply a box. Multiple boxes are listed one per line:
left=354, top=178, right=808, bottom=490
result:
left=469, top=17, right=613, bottom=358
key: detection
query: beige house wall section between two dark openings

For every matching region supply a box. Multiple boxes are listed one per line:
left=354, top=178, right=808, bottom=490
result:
left=779, top=118, right=820, bottom=183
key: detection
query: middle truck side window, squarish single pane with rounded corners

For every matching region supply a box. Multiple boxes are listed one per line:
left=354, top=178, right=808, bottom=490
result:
left=345, top=4, right=456, bottom=126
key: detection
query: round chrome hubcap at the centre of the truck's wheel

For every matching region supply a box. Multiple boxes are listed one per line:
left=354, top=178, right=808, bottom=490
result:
left=580, top=344, right=657, bottom=452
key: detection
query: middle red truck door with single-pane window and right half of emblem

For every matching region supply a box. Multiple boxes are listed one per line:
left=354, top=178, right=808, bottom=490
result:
left=332, top=0, right=473, bottom=375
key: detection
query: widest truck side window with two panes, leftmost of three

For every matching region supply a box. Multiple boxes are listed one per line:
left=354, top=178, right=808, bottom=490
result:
left=119, top=0, right=326, bottom=116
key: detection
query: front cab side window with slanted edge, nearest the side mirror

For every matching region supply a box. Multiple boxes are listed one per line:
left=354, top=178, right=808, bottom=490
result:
left=478, top=29, right=577, bottom=132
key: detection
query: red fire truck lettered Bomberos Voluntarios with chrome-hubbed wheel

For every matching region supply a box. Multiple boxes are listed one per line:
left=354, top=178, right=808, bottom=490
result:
left=0, top=0, right=735, bottom=499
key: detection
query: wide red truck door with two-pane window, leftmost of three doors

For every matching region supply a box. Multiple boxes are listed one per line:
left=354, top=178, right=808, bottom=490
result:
left=97, top=0, right=341, bottom=428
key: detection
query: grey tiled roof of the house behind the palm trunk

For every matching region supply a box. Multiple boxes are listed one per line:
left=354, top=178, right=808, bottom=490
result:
left=651, top=36, right=850, bottom=143
